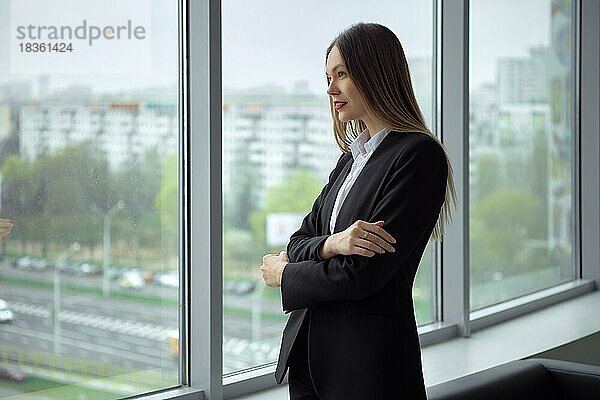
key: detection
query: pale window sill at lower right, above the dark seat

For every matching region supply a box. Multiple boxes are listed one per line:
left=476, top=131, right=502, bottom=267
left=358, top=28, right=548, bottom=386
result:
left=422, top=282, right=600, bottom=386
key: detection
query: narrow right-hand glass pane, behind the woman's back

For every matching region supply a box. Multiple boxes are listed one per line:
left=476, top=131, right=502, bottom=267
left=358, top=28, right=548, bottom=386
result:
left=469, top=0, right=574, bottom=310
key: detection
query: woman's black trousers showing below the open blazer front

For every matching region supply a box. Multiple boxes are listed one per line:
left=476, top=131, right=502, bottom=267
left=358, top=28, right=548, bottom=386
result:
left=288, top=314, right=320, bottom=400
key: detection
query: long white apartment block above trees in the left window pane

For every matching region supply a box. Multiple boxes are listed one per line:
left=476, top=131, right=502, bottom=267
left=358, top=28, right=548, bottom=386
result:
left=19, top=102, right=179, bottom=169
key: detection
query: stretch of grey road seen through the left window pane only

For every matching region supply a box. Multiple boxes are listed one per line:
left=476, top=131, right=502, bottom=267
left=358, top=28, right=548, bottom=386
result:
left=0, top=286, right=177, bottom=371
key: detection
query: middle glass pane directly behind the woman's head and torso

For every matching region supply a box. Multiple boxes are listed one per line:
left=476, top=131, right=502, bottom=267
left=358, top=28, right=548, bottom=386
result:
left=222, top=0, right=433, bottom=375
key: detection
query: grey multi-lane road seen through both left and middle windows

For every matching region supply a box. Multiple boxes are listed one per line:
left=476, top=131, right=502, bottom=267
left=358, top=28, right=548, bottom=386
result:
left=0, top=280, right=283, bottom=373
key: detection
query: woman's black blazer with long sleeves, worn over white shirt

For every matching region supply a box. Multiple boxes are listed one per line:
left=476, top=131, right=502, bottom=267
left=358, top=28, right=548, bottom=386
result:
left=275, top=131, right=448, bottom=400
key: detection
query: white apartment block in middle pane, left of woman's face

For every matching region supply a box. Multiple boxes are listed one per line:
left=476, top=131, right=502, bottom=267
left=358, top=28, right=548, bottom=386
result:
left=223, top=94, right=340, bottom=208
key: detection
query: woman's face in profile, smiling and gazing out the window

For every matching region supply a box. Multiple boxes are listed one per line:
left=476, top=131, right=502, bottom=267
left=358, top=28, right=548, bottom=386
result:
left=325, top=46, right=367, bottom=122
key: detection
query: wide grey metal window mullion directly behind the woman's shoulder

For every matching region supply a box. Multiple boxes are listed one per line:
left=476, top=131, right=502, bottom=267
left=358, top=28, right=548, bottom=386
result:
left=440, top=0, right=470, bottom=337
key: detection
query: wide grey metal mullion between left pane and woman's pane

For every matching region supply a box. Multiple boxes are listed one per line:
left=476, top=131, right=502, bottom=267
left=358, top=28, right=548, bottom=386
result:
left=186, top=0, right=223, bottom=400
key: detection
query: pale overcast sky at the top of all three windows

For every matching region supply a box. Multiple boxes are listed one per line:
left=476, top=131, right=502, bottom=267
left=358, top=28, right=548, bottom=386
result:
left=0, top=0, right=550, bottom=93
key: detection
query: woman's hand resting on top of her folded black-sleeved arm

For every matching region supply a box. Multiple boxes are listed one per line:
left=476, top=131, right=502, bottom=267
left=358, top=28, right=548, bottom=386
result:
left=319, top=219, right=396, bottom=260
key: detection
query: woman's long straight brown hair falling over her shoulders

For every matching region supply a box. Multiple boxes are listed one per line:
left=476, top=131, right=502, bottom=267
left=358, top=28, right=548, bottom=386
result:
left=325, top=22, right=456, bottom=240
